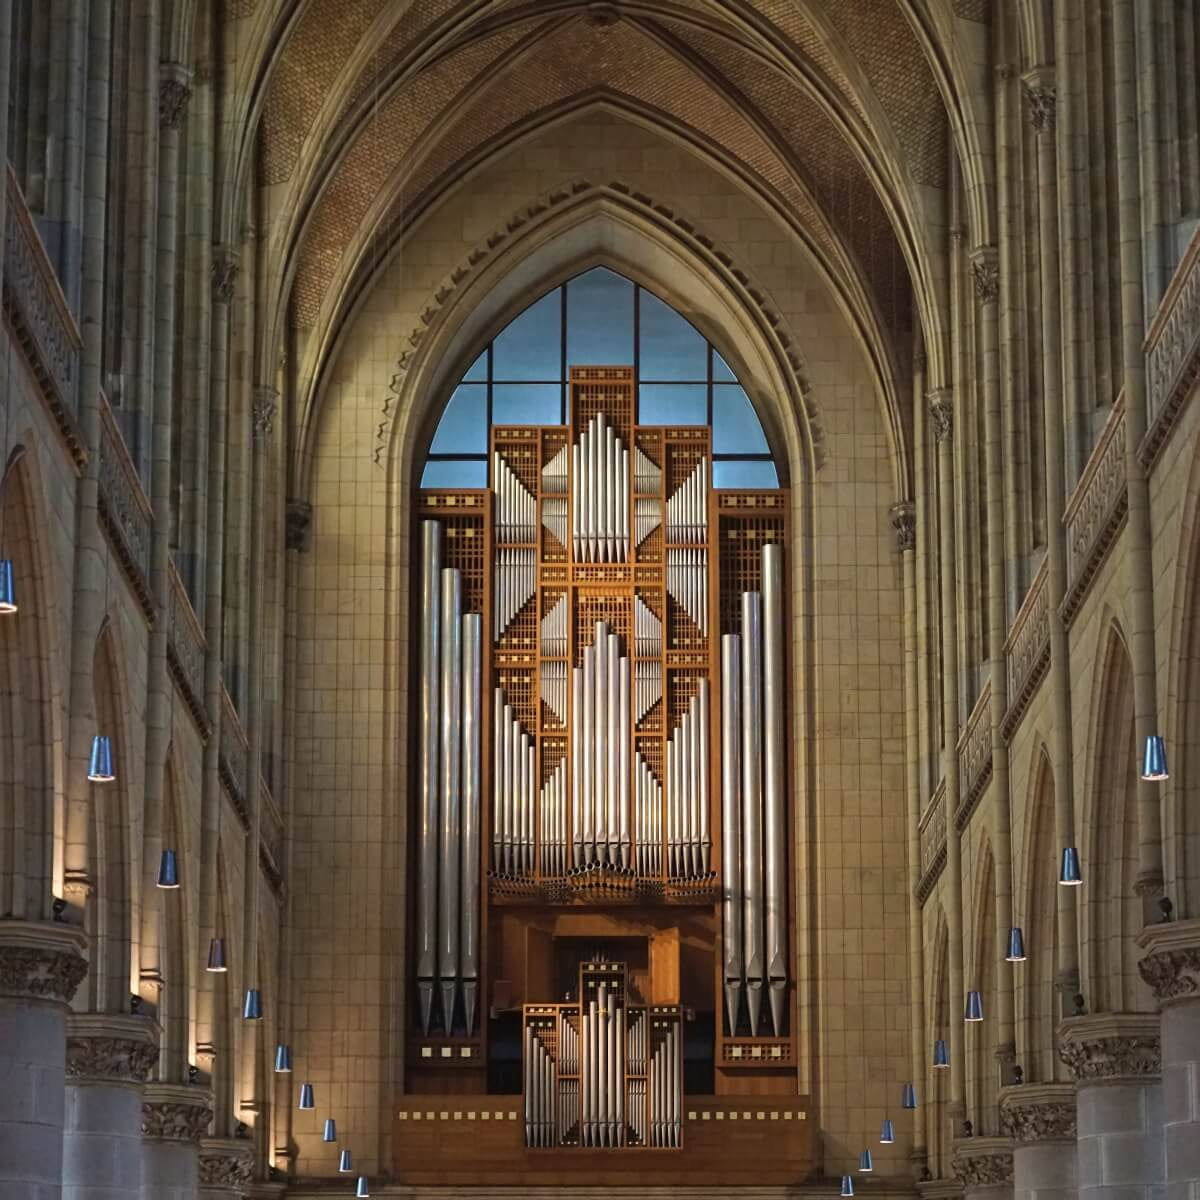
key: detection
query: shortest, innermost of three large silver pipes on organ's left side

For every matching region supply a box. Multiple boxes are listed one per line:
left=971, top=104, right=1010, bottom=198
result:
left=458, top=612, right=484, bottom=1037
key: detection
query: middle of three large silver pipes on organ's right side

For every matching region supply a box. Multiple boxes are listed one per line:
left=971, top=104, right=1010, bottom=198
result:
left=742, top=592, right=763, bottom=1033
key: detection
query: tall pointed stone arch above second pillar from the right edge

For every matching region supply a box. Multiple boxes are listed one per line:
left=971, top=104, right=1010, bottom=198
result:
left=1079, top=618, right=1150, bottom=1013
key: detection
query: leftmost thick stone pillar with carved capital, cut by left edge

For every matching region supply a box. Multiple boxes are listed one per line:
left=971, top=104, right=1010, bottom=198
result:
left=0, top=920, right=88, bottom=1200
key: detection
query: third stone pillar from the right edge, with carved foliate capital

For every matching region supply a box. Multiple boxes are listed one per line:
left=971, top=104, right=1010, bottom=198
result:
left=1000, top=1084, right=1078, bottom=1200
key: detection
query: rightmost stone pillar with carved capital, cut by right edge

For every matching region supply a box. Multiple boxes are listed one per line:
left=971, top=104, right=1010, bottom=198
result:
left=1138, top=919, right=1200, bottom=1200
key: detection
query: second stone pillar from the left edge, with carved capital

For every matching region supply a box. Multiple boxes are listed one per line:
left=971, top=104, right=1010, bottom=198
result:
left=62, top=1013, right=158, bottom=1200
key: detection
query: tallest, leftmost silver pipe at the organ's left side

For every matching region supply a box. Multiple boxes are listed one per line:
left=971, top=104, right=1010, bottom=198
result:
left=416, top=521, right=442, bottom=1034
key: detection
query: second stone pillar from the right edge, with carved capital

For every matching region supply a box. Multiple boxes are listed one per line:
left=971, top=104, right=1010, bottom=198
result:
left=1058, top=1013, right=1164, bottom=1200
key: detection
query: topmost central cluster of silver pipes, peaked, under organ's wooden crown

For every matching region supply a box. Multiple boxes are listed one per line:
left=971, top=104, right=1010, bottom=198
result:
left=571, top=413, right=629, bottom=563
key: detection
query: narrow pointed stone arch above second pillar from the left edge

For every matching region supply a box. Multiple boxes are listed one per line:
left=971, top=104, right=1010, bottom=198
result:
left=86, top=617, right=139, bottom=1013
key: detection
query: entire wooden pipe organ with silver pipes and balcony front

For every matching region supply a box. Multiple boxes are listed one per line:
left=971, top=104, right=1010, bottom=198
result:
left=396, top=367, right=814, bottom=1186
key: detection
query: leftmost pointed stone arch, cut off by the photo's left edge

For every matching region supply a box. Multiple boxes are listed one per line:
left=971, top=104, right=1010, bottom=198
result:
left=0, top=442, right=62, bottom=920
